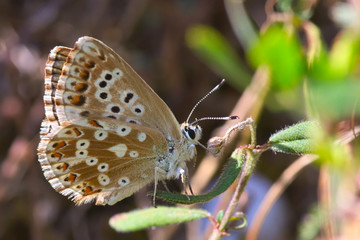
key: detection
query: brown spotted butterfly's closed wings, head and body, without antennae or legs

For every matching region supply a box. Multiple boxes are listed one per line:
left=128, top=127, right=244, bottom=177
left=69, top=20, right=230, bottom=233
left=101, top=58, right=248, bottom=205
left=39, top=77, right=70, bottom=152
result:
left=38, top=37, right=201, bottom=205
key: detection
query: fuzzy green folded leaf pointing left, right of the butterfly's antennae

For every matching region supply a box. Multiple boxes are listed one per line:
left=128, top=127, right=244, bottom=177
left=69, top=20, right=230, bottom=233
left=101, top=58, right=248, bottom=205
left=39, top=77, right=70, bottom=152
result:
left=269, top=121, right=319, bottom=154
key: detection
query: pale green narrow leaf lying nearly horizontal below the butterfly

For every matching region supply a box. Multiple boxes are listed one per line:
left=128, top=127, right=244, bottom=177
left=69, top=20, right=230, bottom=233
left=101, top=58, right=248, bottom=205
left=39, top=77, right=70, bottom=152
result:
left=109, top=207, right=211, bottom=232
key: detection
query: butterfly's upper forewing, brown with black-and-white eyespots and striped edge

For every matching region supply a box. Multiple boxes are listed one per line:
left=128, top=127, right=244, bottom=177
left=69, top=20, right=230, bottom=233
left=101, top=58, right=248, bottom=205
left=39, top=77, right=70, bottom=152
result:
left=43, top=37, right=181, bottom=140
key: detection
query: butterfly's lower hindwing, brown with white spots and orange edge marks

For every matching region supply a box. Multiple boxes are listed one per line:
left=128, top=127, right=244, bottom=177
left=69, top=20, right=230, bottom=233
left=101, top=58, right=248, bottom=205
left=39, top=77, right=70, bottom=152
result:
left=38, top=118, right=168, bottom=205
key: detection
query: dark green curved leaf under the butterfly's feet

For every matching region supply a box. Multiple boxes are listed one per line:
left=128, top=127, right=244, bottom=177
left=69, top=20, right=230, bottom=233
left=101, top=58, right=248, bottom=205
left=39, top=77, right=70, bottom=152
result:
left=149, top=151, right=242, bottom=204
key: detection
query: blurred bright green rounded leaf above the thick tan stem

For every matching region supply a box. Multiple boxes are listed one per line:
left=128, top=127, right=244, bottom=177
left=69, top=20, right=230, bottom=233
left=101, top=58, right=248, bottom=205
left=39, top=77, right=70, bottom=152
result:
left=248, top=24, right=306, bottom=90
